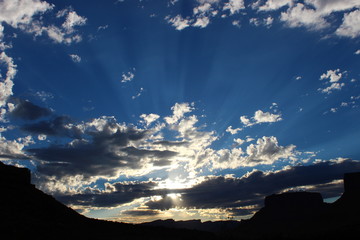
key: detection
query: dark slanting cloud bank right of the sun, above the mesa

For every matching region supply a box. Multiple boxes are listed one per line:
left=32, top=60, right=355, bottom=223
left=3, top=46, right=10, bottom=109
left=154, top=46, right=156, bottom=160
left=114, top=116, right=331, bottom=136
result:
left=146, top=160, right=360, bottom=210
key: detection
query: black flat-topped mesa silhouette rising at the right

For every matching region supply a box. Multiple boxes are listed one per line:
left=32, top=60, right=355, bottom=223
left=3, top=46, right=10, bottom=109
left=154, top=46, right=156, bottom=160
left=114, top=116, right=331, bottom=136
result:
left=229, top=172, right=360, bottom=239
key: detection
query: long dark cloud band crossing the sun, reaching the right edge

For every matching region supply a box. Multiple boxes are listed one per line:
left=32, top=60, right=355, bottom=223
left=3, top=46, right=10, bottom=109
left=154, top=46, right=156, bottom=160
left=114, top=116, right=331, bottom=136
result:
left=53, top=160, right=360, bottom=212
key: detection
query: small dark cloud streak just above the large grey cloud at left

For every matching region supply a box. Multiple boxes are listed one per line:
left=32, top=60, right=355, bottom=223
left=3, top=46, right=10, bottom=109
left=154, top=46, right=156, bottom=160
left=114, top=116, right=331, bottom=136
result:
left=21, top=116, right=82, bottom=138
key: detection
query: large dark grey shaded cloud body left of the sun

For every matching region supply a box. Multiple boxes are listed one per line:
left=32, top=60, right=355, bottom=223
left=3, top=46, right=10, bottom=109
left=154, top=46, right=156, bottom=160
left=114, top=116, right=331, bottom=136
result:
left=27, top=124, right=177, bottom=178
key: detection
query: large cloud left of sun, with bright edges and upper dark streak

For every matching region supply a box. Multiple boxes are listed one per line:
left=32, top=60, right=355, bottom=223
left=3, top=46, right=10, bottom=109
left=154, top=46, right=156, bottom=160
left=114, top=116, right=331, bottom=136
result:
left=23, top=118, right=177, bottom=179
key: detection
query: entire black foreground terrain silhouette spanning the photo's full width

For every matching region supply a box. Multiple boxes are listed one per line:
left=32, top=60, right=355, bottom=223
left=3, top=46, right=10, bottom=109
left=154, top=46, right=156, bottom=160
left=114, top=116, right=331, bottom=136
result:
left=0, top=162, right=360, bottom=240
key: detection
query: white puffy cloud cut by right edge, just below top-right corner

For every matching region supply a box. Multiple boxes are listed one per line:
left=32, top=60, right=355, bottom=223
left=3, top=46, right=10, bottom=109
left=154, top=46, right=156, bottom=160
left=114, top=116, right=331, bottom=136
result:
left=335, top=9, right=360, bottom=38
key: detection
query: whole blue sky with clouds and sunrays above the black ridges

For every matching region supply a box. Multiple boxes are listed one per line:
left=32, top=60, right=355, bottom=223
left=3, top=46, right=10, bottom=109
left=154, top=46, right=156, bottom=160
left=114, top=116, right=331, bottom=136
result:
left=0, top=0, right=360, bottom=223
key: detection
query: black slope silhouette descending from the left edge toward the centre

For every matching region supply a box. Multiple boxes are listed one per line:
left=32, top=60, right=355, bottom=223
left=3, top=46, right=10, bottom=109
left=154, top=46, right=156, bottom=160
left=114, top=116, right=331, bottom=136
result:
left=0, top=162, right=216, bottom=240
